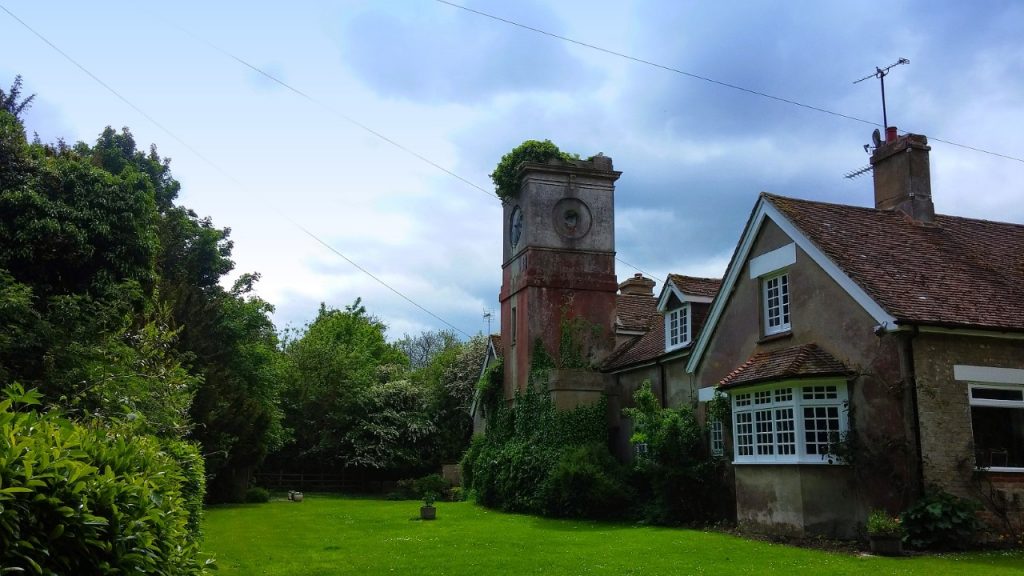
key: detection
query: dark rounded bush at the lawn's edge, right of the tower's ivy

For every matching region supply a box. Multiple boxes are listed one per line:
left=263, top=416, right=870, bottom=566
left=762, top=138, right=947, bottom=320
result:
left=544, top=444, right=630, bottom=519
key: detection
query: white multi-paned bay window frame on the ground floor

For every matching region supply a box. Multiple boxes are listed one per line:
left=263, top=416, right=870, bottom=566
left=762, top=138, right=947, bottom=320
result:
left=729, top=379, right=850, bottom=464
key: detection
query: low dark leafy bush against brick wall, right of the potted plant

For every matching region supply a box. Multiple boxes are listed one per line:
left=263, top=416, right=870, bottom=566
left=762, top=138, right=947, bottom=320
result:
left=900, top=491, right=981, bottom=548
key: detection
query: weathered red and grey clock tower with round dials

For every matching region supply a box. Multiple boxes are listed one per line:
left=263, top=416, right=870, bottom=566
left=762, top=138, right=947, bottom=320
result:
left=500, top=155, right=622, bottom=408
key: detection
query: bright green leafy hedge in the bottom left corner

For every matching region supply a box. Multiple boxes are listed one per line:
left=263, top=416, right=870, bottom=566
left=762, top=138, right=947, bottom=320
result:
left=0, top=386, right=205, bottom=575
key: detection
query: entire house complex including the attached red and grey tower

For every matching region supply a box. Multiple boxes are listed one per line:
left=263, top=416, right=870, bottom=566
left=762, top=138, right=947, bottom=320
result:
left=491, top=134, right=1024, bottom=537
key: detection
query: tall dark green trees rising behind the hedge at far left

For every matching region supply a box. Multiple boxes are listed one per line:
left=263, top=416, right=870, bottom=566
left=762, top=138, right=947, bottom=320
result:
left=0, top=91, right=284, bottom=499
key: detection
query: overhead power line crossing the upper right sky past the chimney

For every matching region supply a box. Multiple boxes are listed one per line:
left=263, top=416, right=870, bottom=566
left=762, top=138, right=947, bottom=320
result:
left=434, top=0, right=1024, bottom=164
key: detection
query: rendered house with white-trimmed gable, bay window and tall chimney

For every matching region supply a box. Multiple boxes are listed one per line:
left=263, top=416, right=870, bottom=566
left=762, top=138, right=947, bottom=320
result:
left=686, top=130, right=1024, bottom=537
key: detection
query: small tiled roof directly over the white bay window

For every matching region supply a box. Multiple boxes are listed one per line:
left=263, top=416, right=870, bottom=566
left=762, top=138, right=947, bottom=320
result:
left=719, top=344, right=850, bottom=387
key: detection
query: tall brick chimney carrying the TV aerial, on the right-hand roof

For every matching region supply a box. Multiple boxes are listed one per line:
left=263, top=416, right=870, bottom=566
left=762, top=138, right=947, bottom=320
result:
left=871, top=128, right=935, bottom=223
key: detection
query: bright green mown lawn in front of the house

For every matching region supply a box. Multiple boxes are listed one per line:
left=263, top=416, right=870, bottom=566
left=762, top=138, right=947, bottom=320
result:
left=205, top=494, right=1024, bottom=576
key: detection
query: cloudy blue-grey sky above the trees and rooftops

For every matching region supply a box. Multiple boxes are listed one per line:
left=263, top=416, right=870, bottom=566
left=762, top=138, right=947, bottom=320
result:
left=0, top=0, right=1024, bottom=338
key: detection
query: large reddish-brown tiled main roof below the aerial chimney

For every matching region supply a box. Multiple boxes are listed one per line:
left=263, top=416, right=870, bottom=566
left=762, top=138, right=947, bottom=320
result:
left=762, top=194, right=1024, bottom=330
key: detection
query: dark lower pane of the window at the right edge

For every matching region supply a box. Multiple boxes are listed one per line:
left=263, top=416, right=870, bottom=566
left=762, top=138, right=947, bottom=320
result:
left=971, top=406, right=1024, bottom=468
